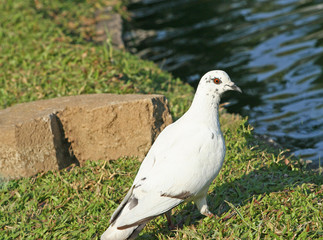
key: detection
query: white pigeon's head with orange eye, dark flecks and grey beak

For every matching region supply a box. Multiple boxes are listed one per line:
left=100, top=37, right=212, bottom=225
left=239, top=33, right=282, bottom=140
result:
left=198, top=70, right=242, bottom=96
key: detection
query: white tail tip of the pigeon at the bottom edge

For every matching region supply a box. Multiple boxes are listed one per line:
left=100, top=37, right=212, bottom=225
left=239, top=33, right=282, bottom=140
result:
left=101, top=223, right=146, bottom=240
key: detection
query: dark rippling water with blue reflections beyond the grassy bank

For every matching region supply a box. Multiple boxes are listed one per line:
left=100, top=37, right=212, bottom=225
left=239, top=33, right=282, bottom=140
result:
left=124, top=0, right=323, bottom=167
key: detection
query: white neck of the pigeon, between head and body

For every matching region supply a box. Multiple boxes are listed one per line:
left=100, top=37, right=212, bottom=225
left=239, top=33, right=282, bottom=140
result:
left=187, top=89, right=220, bottom=130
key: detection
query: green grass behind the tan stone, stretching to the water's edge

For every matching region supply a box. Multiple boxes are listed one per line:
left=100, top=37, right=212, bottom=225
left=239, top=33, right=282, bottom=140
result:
left=0, top=0, right=192, bottom=117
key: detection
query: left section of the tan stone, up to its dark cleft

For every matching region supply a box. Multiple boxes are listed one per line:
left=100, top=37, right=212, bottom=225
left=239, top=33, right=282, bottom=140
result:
left=0, top=101, right=75, bottom=178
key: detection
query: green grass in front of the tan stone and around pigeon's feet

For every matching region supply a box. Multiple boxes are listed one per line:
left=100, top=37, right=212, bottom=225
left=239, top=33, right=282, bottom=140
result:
left=0, top=116, right=323, bottom=239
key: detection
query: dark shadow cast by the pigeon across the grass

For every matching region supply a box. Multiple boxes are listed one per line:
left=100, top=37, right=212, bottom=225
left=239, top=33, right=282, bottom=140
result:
left=140, top=148, right=323, bottom=239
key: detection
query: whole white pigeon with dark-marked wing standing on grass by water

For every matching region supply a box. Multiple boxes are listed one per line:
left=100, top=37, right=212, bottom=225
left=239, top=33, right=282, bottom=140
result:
left=101, top=70, right=241, bottom=240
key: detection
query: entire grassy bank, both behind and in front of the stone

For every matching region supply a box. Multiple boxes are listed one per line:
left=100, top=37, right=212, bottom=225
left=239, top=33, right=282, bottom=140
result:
left=0, top=0, right=323, bottom=239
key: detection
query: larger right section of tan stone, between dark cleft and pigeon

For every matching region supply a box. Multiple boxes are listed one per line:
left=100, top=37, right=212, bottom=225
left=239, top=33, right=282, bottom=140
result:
left=57, top=94, right=172, bottom=164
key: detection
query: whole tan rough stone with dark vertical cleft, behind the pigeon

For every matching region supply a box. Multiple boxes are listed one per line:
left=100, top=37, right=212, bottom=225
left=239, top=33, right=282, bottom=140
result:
left=0, top=94, right=172, bottom=178
